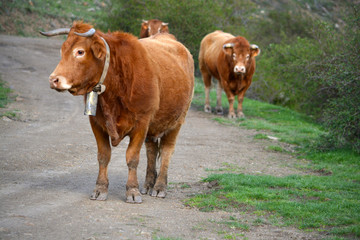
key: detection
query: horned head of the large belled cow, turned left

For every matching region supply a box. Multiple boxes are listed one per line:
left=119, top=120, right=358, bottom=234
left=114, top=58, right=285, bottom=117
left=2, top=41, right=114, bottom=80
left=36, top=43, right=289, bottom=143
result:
left=42, top=22, right=106, bottom=95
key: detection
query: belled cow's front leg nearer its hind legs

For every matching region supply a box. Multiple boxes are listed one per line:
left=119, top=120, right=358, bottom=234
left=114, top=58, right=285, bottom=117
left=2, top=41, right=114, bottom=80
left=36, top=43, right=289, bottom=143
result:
left=126, top=129, right=146, bottom=203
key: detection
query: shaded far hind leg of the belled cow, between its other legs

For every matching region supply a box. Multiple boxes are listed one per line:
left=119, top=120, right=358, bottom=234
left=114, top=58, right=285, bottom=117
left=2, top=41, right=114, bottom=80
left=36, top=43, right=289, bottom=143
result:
left=141, top=138, right=159, bottom=194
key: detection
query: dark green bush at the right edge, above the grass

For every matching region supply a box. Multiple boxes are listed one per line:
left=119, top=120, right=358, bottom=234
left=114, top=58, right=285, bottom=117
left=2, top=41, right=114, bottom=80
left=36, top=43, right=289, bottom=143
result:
left=314, top=6, right=360, bottom=153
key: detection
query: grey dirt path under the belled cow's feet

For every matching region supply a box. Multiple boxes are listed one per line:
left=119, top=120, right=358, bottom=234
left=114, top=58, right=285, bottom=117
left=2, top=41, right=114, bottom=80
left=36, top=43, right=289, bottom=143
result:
left=0, top=35, right=319, bottom=239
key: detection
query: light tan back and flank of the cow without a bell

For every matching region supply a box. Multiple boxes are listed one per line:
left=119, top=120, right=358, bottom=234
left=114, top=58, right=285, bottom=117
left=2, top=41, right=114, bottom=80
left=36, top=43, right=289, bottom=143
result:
left=199, top=30, right=235, bottom=79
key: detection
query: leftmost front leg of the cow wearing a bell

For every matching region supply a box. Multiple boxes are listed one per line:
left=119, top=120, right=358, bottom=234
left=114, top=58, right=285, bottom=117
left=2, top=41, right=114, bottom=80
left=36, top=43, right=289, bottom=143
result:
left=90, top=117, right=111, bottom=201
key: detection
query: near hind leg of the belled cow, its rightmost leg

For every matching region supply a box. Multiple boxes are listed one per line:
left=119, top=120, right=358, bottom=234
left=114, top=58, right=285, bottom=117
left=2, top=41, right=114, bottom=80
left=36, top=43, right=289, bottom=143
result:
left=151, top=124, right=181, bottom=198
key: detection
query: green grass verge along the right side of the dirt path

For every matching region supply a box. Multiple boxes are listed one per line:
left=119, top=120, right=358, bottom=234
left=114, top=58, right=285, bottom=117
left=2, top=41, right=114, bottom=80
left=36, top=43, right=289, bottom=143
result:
left=190, top=80, right=360, bottom=239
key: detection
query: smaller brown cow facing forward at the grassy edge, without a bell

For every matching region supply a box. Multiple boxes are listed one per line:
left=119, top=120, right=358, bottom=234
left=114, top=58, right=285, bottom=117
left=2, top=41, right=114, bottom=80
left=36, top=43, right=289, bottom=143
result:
left=199, top=31, right=260, bottom=118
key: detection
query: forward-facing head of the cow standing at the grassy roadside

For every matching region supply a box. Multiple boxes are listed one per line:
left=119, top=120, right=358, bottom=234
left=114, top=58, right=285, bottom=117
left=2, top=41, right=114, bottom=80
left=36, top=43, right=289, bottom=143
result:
left=223, top=37, right=260, bottom=74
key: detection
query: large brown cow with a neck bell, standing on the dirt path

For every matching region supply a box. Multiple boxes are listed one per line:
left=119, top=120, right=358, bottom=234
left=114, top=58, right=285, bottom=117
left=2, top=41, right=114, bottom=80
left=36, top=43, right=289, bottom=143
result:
left=43, top=22, right=194, bottom=203
